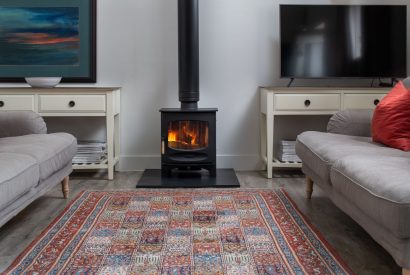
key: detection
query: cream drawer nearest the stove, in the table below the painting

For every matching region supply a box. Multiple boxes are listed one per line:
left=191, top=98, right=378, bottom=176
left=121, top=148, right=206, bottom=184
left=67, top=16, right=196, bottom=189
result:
left=39, top=95, right=106, bottom=113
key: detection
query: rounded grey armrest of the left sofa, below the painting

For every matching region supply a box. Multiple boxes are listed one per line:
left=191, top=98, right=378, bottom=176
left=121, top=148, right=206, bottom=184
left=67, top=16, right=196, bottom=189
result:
left=0, top=111, right=47, bottom=138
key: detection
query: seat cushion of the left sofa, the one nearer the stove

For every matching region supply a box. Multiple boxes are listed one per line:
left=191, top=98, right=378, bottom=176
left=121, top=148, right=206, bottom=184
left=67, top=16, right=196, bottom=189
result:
left=0, top=133, right=77, bottom=181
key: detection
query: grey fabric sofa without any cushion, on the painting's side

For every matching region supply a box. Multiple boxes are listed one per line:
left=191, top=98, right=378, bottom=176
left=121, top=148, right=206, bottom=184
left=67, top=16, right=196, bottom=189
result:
left=0, top=112, right=77, bottom=227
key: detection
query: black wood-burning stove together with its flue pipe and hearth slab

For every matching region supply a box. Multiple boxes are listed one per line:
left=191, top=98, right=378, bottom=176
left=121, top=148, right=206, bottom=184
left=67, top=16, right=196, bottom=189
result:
left=137, top=0, right=240, bottom=188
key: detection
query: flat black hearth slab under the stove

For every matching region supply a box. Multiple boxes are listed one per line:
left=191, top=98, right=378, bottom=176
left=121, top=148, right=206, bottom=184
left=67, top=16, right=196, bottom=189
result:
left=136, top=169, right=240, bottom=188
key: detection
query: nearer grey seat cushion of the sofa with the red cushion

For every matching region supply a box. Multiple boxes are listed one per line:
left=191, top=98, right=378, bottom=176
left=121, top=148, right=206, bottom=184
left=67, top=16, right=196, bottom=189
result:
left=331, top=155, right=410, bottom=238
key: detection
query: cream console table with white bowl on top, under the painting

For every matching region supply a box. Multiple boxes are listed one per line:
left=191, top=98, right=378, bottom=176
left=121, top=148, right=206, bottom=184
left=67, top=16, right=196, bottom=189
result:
left=0, top=88, right=120, bottom=180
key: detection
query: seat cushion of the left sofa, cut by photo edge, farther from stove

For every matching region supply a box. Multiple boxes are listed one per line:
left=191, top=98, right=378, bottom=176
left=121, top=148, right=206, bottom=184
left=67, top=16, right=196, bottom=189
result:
left=0, top=153, right=40, bottom=209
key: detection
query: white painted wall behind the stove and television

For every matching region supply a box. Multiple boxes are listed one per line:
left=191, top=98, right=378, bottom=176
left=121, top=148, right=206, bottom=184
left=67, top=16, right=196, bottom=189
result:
left=1, top=0, right=410, bottom=170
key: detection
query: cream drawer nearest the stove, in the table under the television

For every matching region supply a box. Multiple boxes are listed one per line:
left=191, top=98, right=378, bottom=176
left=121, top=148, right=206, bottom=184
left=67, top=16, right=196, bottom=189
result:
left=274, top=94, right=340, bottom=111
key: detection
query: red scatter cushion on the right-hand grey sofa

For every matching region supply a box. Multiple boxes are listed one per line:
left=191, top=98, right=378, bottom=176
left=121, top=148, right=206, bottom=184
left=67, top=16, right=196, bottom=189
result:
left=372, top=82, right=410, bottom=151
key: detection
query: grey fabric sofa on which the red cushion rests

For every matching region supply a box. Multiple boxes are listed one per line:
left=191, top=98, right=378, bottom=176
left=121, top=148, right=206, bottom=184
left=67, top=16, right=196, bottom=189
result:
left=296, top=110, right=410, bottom=274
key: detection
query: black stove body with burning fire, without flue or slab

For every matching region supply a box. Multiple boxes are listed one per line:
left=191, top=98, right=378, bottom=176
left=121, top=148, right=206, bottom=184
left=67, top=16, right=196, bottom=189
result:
left=160, top=109, right=217, bottom=176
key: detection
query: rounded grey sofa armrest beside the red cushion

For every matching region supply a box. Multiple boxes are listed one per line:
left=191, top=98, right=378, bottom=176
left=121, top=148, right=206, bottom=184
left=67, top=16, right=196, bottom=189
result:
left=327, top=110, right=373, bottom=137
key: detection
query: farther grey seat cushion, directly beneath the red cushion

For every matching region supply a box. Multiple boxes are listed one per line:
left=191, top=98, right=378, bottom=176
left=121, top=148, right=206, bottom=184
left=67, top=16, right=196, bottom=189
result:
left=296, top=131, right=410, bottom=183
